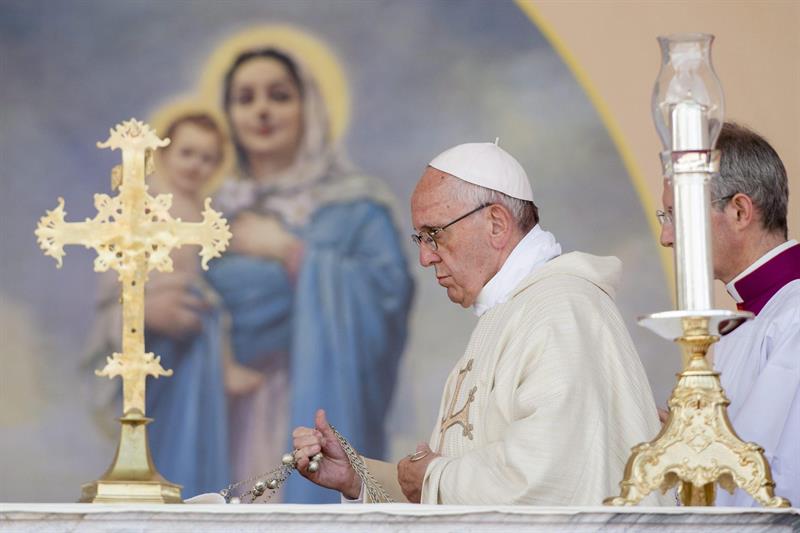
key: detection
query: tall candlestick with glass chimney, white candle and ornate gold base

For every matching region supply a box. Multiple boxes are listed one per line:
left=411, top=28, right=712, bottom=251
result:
left=604, top=34, right=789, bottom=507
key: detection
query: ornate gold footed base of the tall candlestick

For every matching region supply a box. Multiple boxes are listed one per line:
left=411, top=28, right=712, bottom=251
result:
left=603, top=317, right=789, bottom=507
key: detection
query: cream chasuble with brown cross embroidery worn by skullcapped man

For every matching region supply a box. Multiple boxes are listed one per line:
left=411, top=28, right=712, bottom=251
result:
left=422, top=252, right=669, bottom=505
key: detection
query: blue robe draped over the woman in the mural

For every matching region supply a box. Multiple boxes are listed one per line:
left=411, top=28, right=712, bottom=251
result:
left=208, top=200, right=413, bottom=503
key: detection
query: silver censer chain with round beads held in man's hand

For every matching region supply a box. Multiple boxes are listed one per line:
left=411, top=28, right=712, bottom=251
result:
left=219, top=426, right=394, bottom=503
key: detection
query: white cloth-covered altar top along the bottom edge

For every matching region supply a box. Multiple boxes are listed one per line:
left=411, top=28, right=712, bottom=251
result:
left=0, top=503, right=800, bottom=533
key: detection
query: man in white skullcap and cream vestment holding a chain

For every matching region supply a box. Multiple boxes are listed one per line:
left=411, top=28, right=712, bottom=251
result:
left=293, top=143, right=659, bottom=505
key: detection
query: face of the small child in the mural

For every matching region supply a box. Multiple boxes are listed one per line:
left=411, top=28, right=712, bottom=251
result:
left=159, top=122, right=222, bottom=194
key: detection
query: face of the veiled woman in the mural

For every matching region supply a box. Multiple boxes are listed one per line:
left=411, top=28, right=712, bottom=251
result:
left=228, top=58, right=303, bottom=164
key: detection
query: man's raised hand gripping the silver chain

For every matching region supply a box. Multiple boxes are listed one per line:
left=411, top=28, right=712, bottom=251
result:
left=292, top=409, right=361, bottom=500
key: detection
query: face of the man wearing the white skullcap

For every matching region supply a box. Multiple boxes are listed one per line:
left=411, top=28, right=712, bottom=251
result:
left=411, top=167, right=496, bottom=307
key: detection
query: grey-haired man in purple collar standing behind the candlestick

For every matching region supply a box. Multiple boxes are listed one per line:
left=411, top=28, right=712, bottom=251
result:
left=659, top=123, right=800, bottom=506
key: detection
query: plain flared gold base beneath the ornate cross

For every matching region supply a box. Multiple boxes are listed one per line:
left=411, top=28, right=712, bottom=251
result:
left=80, top=409, right=182, bottom=503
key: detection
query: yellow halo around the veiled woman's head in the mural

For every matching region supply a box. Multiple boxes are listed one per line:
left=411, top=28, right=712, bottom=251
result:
left=200, top=24, right=350, bottom=141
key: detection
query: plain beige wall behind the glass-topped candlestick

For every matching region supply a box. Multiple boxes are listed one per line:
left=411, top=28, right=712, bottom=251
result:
left=533, top=0, right=800, bottom=307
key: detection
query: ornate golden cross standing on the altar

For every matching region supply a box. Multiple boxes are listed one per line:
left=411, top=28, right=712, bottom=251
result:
left=36, top=119, right=231, bottom=501
